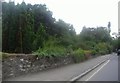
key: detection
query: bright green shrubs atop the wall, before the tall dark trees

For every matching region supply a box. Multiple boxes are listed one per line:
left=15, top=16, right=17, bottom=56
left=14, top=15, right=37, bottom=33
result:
left=34, top=37, right=66, bottom=56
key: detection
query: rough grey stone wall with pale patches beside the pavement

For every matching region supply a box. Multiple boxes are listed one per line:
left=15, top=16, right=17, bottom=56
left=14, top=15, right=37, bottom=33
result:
left=2, top=54, right=74, bottom=80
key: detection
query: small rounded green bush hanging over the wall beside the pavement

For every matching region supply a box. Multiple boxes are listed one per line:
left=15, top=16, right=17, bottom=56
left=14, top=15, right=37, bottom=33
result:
left=73, top=48, right=85, bottom=63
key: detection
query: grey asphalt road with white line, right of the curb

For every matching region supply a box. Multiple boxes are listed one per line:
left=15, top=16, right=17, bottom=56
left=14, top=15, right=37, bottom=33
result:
left=78, top=54, right=120, bottom=81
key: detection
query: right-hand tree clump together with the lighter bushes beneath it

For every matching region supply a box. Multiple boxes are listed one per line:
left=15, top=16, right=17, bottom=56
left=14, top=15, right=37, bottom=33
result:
left=78, top=27, right=113, bottom=55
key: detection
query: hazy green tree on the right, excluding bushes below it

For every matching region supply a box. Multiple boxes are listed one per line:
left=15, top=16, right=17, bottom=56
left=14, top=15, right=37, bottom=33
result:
left=79, top=27, right=112, bottom=50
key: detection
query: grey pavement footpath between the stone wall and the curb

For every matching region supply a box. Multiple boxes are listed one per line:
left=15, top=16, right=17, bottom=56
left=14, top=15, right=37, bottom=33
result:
left=3, top=54, right=113, bottom=81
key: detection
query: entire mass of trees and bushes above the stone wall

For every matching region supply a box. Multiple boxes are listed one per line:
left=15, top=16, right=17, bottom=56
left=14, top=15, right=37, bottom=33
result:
left=2, top=2, right=116, bottom=59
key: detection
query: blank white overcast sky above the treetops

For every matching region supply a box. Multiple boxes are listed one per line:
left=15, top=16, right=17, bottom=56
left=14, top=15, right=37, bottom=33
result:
left=5, top=0, right=120, bottom=34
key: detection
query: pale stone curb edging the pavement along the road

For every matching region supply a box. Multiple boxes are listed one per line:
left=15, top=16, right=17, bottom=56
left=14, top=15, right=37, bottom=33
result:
left=69, top=60, right=107, bottom=83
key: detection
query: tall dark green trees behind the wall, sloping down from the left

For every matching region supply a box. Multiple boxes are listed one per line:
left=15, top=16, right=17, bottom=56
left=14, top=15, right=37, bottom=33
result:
left=2, top=1, right=76, bottom=53
